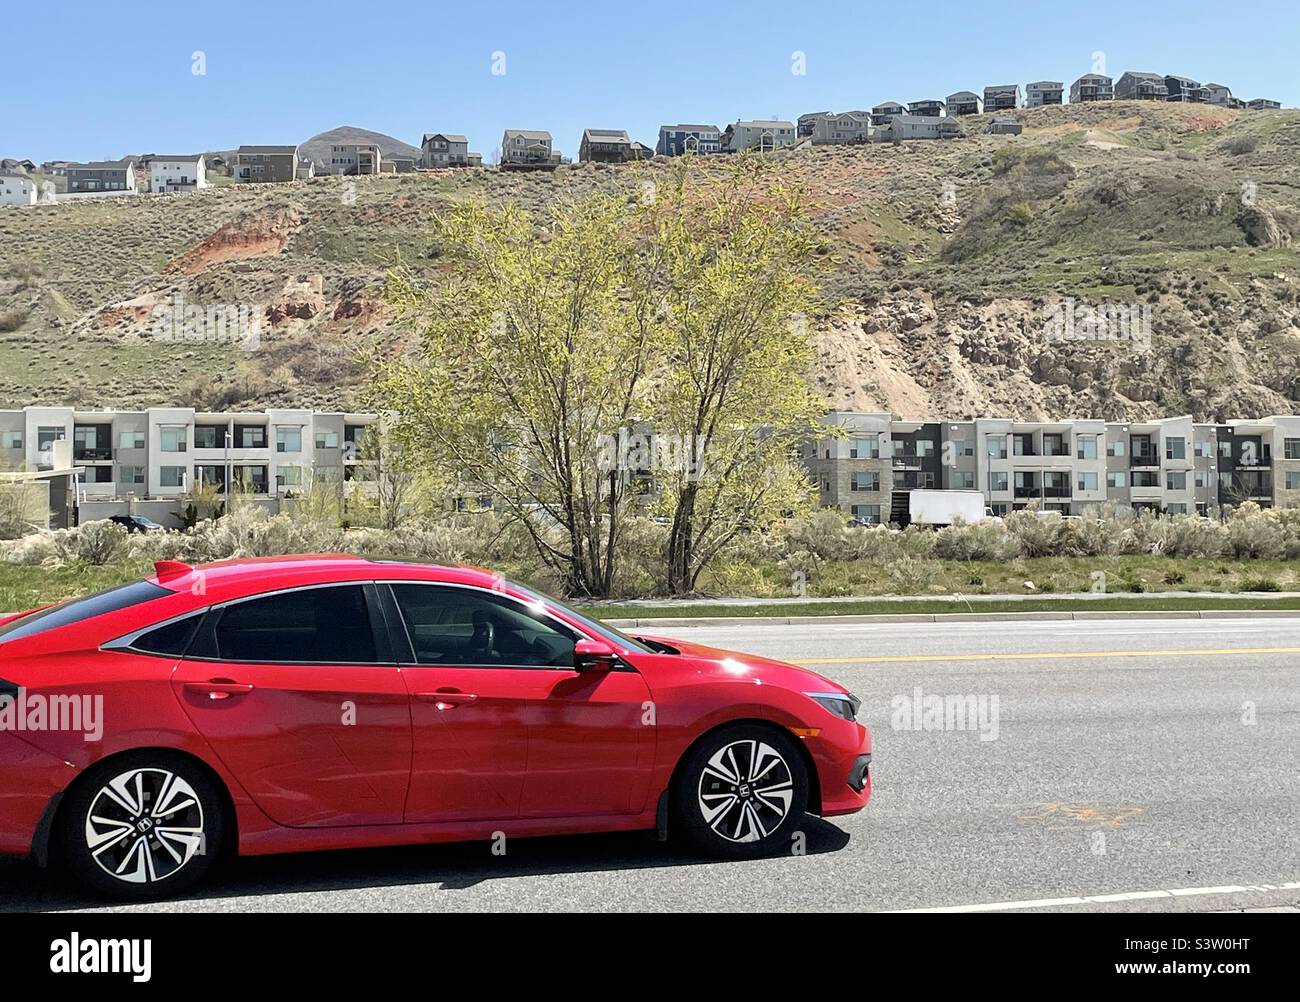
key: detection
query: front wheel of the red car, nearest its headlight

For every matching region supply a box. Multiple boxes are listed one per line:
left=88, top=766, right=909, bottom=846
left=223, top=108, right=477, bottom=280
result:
left=672, top=724, right=809, bottom=859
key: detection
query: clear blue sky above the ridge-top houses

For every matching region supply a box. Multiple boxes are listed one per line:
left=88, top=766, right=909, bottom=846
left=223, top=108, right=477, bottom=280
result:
left=0, top=0, right=1300, bottom=162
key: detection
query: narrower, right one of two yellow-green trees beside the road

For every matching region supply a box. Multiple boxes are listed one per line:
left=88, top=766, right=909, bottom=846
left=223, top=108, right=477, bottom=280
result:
left=644, top=159, right=824, bottom=594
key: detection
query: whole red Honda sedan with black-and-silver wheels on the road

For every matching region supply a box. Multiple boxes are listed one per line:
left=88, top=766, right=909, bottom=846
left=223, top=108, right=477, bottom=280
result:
left=0, top=556, right=871, bottom=899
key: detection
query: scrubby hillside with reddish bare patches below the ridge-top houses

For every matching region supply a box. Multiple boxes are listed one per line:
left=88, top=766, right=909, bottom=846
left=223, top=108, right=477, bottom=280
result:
left=0, top=103, right=1300, bottom=418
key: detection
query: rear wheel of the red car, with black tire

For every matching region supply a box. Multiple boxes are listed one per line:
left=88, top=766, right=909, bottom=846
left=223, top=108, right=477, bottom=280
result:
left=59, top=751, right=226, bottom=901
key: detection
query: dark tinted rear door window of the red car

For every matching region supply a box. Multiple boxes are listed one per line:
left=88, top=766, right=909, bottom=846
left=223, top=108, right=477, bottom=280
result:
left=216, top=585, right=377, bottom=664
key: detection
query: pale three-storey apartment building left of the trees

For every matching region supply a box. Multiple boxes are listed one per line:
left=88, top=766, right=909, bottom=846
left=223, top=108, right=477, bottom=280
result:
left=0, top=407, right=376, bottom=500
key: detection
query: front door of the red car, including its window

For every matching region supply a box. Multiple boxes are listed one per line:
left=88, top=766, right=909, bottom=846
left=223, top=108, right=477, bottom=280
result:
left=379, top=582, right=654, bottom=821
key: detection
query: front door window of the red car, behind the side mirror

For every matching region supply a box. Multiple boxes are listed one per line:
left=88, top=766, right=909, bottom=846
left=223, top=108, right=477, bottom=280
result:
left=393, top=584, right=579, bottom=668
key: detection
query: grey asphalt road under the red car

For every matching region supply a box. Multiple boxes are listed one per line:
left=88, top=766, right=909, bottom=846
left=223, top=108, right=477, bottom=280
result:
left=0, top=619, right=1300, bottom=911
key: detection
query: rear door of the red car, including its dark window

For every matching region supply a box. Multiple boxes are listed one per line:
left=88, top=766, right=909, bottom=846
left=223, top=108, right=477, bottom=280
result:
left=172, top=582, right=411, bottom=828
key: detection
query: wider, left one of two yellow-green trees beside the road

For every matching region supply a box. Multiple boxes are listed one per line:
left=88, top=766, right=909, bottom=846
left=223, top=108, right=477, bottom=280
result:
left=371, top=195, right=654, bottom=595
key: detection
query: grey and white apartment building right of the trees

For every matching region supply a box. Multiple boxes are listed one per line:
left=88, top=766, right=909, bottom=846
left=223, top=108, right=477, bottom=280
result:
left=803, top=411, right=1300, bottom=524
